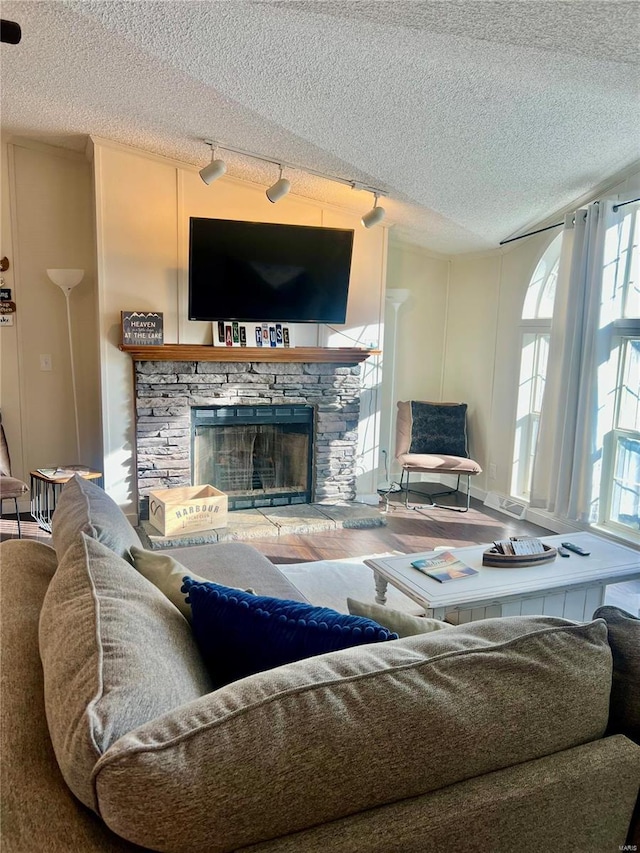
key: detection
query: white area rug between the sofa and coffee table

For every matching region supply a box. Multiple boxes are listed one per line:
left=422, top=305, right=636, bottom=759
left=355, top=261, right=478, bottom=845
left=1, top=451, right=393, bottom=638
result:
left=278, top=552, right=424, bottom=615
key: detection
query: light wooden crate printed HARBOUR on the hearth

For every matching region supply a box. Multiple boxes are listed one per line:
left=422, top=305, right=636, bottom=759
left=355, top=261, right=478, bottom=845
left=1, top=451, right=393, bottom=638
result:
left=149, top=485, right=228, bottom=536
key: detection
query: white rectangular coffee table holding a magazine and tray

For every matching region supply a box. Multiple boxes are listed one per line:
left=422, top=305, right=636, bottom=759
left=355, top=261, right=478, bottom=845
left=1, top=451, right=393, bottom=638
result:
left=365, top=533, right=640, bottom=622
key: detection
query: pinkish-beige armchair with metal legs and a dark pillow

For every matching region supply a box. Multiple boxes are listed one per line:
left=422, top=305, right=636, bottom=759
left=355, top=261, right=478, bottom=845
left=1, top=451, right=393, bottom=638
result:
left=396, top=400, right=482, bottom=512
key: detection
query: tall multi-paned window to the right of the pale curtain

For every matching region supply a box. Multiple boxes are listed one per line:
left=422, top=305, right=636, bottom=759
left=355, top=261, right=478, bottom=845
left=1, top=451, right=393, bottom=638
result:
left=592, top=204, right=640, bottom=537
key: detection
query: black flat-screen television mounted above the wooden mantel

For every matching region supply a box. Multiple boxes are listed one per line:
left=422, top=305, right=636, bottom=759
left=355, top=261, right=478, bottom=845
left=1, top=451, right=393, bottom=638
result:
left=189, top=217, right=353, bottom=323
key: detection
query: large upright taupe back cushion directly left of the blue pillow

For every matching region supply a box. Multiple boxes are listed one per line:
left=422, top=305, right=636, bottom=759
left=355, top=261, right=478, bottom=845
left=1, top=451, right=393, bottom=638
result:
left=39, top=533, right=211, bottom=809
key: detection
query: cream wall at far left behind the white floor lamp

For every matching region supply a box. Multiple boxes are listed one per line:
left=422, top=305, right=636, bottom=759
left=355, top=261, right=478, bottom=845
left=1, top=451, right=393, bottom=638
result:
left=0, top=135, right=102, bottom=500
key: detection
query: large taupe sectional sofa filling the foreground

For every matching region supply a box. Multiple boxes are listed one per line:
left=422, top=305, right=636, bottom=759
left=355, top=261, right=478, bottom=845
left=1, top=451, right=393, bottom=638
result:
left=1, top=478, right=640, bottom=853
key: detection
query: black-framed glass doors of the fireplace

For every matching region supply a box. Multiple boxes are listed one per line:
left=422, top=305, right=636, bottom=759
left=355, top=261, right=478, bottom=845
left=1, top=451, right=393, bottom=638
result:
left=192, top=406, right=313, bottom=509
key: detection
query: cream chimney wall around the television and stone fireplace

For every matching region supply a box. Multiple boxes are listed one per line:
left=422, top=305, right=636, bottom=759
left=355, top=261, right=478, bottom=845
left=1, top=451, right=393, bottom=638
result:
left=93, top=139, right=386, bottom=514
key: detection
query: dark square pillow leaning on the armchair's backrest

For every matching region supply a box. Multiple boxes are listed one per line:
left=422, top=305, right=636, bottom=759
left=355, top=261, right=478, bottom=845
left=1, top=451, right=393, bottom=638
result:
left=409, top=401, right=469, bottom=458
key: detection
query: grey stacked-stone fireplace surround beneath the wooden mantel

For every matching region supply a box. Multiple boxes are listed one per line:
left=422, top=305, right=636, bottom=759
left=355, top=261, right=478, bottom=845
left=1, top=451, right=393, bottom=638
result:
left=134, top=354, right=361, bottom=519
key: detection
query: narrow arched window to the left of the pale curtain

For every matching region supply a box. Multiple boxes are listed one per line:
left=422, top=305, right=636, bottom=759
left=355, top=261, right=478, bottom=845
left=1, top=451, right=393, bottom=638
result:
left=511, top=234, right=562, bottom=500
